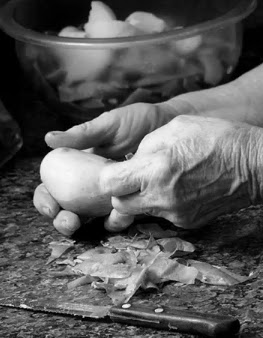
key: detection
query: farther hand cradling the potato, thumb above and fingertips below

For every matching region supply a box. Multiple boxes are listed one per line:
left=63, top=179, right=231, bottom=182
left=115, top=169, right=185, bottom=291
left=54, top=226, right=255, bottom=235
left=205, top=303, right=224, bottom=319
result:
left=34, top=103, right=179, bottom=236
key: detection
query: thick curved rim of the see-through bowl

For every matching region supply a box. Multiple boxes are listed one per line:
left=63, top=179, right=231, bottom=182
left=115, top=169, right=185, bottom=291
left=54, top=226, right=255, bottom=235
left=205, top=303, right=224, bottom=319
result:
left=0, top=0, right=257, bottom=49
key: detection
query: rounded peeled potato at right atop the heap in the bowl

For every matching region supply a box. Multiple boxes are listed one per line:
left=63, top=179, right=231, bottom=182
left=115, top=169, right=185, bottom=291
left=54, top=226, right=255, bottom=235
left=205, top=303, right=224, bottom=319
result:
left=125, top=12, right=166, bottom=34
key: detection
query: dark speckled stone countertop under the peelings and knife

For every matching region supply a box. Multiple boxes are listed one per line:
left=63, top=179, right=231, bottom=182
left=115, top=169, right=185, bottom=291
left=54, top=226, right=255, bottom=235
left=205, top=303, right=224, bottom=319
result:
left=0, top=157, right=263, bottom=338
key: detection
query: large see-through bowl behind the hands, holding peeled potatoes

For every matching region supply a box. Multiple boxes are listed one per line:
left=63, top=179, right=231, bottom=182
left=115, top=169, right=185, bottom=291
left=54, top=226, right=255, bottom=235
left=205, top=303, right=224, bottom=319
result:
left=0, top=0, right=256, bottom=123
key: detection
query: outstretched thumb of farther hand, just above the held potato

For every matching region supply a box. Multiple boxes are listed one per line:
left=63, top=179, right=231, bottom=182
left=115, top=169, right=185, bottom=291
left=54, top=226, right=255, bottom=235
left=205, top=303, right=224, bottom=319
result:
left=45, top=113, right=119, bottom=149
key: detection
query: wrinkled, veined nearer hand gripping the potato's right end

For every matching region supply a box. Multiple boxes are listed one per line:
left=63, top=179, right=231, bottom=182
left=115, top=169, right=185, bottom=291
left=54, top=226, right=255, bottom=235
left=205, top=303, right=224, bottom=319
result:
left=101, top=116, right=262, bottom=231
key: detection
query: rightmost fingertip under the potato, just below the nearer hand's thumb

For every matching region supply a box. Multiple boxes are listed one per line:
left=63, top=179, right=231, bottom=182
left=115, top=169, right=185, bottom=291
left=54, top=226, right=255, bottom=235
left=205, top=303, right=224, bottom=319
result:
left=104, top=209, right=134, bottom=232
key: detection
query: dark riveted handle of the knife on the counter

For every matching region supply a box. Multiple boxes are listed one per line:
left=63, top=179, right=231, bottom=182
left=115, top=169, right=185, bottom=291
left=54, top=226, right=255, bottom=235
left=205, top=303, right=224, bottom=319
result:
left=109, top=304, right=240, bottom=338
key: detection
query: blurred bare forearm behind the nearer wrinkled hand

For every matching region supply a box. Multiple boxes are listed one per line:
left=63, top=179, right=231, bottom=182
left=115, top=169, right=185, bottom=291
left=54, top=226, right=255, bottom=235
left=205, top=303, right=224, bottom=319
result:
left=165, top=65, right=263, bottom=127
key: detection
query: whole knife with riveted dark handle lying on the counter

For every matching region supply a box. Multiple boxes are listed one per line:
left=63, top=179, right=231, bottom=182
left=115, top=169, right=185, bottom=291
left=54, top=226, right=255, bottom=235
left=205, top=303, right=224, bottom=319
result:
left=0, top=299, right=240, bottom=338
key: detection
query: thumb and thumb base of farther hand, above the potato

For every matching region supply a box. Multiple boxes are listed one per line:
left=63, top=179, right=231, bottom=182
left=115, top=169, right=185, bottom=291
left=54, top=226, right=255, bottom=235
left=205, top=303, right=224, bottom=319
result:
left=45, top=103, right=178, bottom=159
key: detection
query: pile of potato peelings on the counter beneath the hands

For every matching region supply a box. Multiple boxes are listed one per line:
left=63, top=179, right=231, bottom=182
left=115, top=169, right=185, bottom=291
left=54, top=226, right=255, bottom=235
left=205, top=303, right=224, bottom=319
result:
left=47, top=224, right=254, bottom=305
